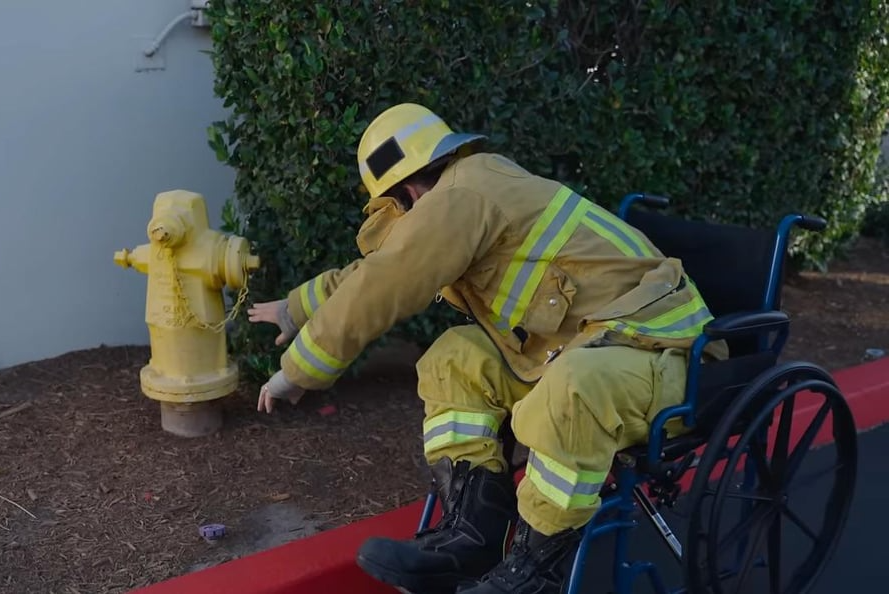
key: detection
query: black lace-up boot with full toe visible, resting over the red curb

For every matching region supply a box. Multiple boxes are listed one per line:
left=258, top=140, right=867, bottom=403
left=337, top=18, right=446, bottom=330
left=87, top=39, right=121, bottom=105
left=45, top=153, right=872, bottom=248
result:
left=357, top=458, right=518, bottom=594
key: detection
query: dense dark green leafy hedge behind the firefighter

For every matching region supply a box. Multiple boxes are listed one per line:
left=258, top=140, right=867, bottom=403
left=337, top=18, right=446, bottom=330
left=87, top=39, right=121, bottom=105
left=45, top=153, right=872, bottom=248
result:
left=210, top=0, right=889, bottom=374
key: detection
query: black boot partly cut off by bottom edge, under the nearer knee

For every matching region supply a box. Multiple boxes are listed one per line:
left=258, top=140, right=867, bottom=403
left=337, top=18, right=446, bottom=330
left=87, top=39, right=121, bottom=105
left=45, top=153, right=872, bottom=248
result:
left=458, top=520, right=581, bottom=594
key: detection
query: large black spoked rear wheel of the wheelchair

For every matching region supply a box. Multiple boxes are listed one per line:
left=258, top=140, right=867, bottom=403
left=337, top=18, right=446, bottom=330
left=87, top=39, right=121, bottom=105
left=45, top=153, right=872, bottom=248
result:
left=683, top=363, right=858, bottom=594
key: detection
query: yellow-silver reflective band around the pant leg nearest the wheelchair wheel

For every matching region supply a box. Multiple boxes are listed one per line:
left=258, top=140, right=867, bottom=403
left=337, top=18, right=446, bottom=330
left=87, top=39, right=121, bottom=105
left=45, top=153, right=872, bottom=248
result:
left=527, top=450, right=608, bottom=509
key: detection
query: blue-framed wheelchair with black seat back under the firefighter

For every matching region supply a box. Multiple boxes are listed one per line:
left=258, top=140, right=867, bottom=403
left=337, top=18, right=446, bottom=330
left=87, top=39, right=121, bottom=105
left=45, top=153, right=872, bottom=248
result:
left=419, top=194, right=858, bottom=594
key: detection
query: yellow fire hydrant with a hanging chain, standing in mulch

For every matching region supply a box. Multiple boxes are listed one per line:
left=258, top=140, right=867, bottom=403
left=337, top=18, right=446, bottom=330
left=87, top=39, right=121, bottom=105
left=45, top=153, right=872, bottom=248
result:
left=114, top=190, right=259, bottom=437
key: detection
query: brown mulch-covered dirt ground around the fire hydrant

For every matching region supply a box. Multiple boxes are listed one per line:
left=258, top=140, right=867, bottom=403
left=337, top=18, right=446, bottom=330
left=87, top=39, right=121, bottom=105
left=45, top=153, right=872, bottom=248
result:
left=0, top=239, right=889, bottom=594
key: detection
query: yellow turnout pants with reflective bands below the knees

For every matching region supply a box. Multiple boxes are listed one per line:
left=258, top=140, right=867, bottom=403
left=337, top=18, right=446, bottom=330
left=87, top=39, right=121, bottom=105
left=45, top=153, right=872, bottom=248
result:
left=417, top=326, right=687, bottom=535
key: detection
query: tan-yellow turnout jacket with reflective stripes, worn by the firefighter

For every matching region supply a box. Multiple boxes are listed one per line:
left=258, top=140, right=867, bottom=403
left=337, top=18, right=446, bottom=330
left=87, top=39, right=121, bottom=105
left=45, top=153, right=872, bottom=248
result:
left=281, top=153, right=724, bottom=389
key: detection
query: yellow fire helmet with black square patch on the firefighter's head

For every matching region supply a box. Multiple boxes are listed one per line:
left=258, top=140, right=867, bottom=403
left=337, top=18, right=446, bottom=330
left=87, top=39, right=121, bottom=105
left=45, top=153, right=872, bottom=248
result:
left=358, top=103, right=486, bottom=198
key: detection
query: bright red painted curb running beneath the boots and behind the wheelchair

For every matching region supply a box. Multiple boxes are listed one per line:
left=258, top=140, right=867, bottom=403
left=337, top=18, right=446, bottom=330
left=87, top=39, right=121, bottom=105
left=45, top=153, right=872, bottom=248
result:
left=132, top=358, right=889, bottom=594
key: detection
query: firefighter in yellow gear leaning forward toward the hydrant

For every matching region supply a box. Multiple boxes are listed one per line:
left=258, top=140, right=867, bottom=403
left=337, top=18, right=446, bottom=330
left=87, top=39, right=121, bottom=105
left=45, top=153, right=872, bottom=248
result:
left=249, top=104, right=724, bottom=594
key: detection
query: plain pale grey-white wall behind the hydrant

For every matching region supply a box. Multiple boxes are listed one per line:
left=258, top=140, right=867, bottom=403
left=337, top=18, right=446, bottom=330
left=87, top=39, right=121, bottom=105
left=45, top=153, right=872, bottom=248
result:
left=0, top=0, right=234, bottom=368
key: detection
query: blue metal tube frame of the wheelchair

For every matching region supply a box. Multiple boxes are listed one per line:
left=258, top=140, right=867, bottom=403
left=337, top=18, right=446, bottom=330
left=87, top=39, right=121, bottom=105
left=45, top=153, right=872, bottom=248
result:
left=419, top=193, right=825, bottom=594
